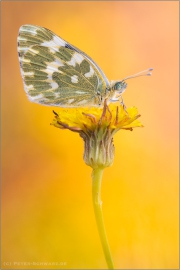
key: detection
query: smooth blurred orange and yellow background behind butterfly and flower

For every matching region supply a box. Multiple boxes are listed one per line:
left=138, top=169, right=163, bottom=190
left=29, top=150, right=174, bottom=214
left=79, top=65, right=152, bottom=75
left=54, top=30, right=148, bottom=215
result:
left=1, top=1, right=179, bottom=269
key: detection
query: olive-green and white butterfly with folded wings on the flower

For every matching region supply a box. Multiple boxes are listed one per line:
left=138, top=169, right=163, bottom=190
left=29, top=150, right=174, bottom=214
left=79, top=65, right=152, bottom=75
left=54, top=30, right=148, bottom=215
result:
left=18, top=24, right=152, bottom=107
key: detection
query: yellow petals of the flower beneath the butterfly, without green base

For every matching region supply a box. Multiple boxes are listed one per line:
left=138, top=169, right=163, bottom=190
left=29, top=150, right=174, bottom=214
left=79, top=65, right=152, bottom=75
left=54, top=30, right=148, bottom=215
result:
left=52, top=103, right=142, bottom=133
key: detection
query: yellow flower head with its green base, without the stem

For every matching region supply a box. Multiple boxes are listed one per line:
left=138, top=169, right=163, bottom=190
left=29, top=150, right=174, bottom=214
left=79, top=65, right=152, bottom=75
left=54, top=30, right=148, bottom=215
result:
left=51, top=101, right=142, bottom=168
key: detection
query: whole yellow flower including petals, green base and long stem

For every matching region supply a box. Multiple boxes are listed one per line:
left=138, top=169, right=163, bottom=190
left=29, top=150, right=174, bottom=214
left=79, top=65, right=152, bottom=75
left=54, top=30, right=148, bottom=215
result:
left=51, top=101, right=142, bottom=269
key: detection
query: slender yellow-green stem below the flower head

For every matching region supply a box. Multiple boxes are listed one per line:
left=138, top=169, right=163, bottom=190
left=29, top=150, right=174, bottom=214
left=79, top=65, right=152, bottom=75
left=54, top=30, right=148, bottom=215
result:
left=92, top=168, right=114, bottom=269
